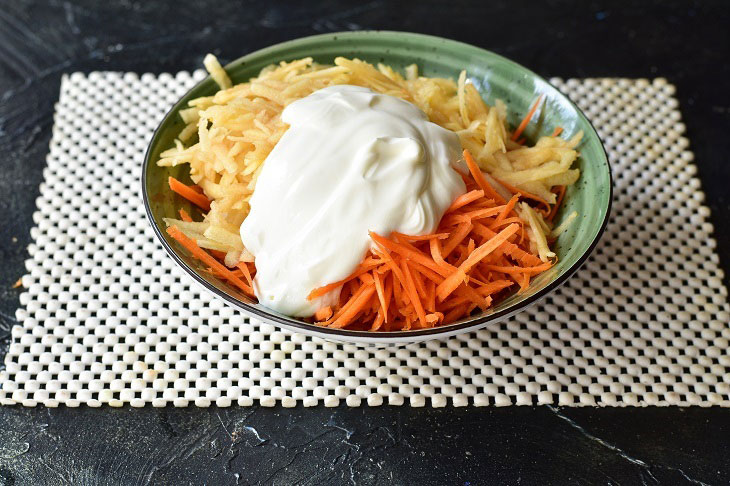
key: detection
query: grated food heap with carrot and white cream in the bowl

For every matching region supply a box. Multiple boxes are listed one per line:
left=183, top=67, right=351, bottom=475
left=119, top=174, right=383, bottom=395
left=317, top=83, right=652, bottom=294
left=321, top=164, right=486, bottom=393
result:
left=158, top=56, right=582, bottom=331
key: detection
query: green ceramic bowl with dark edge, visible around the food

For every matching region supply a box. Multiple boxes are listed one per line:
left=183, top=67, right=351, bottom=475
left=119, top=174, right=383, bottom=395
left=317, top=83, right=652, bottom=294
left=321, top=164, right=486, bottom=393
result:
left=142, top=31, right=612, bottom=344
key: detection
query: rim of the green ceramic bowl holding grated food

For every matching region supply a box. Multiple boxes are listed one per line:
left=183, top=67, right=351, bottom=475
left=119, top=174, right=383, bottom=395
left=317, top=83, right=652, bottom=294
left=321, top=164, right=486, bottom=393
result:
left=140, top=30, right=613, bottom=343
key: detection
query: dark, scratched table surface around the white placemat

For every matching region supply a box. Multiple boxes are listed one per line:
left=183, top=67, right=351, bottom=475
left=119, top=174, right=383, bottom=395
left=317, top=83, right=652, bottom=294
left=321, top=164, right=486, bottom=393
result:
left=0, top=0, right=730, bottom=485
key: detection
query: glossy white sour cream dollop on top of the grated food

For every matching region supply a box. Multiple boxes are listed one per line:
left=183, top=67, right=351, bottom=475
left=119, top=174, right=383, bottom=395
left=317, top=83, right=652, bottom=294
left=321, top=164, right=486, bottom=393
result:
left=241, top=85, right=466, bottom=317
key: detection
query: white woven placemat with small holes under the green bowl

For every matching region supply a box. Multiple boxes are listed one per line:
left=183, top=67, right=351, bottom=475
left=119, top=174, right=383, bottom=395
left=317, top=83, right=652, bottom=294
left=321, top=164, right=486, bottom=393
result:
left=0, top=73, right=730, bottom=407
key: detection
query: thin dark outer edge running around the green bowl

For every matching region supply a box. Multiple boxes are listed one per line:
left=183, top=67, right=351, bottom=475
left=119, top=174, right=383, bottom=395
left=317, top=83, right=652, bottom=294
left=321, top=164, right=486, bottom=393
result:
left=141, top=31, right=613, bottom=344
